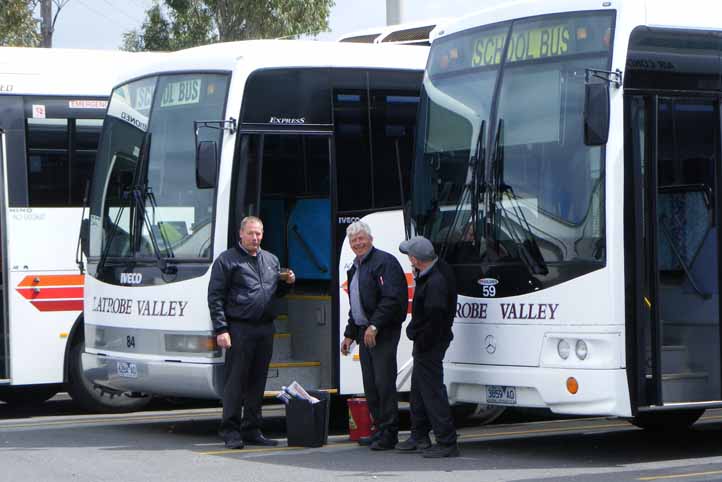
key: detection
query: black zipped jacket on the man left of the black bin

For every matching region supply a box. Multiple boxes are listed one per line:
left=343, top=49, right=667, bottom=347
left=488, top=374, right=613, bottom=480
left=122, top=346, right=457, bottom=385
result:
left=208, top=245, right=288, bottom=334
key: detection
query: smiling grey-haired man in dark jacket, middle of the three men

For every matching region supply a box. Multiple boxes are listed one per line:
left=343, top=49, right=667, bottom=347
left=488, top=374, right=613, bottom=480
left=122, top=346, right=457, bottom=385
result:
left=341, top=221, right=409, bottom=450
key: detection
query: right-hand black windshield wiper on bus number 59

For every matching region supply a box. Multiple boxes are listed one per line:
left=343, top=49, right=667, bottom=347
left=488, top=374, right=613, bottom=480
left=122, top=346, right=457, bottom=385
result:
left=486, top=118, right=549, bottom=275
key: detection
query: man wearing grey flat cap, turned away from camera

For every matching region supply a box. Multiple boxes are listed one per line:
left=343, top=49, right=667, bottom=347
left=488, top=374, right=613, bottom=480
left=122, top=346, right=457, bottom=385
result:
left=396, top=236, right=459, bottom=458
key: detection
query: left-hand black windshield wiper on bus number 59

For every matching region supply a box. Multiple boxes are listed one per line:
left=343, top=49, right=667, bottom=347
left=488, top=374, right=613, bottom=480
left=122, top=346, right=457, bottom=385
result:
left=439, top=120, right=486, bottom=257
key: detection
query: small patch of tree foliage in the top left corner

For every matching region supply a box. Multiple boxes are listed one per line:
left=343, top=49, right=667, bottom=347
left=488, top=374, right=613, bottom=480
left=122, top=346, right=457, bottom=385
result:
left=0, top=0, right=40, bottom=47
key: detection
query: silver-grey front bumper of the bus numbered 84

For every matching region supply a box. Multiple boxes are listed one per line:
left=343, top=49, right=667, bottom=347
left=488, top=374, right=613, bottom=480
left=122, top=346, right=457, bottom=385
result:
left=83, top=352, right=223, bottom=399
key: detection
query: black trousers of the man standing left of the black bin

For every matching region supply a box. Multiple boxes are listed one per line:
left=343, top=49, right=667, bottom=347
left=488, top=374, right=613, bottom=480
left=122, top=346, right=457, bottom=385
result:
left=220, top=322, right=275, bottom=436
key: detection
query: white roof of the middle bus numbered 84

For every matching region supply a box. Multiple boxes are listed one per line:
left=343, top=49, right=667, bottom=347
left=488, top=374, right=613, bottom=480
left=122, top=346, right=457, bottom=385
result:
left=113, top=40, right=429, bottom=86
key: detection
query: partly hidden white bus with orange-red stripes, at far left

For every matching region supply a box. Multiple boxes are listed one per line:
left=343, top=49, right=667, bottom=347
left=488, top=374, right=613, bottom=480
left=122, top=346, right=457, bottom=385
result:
left=0, top=48, right=157, bottom=410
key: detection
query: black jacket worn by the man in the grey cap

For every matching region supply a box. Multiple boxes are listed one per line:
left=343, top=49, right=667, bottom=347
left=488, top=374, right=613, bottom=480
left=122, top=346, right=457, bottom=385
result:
left=406, top=259, right=457, bottom=352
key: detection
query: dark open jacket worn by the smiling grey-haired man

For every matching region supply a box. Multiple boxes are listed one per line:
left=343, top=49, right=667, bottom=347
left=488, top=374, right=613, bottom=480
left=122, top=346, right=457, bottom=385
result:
left=343, top=248, right=409, bottom=339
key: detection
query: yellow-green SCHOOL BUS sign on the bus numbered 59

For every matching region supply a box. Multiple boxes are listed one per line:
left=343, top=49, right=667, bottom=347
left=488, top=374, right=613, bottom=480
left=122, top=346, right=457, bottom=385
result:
left=471, top=25, right=571, bottom=67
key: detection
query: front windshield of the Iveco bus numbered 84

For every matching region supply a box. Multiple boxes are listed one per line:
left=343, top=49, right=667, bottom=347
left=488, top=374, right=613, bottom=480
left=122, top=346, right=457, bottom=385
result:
left=90, top=74, right=228, bottom=261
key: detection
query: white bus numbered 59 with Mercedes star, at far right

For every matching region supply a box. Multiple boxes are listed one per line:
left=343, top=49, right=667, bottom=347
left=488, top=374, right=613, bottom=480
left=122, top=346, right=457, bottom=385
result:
left=410, top=0, right=722, bottom=427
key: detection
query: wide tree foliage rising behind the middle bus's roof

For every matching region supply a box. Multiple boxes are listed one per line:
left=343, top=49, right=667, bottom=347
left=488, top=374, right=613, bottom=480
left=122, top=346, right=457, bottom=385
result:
left=122, top=0, right=334, bottom=51
